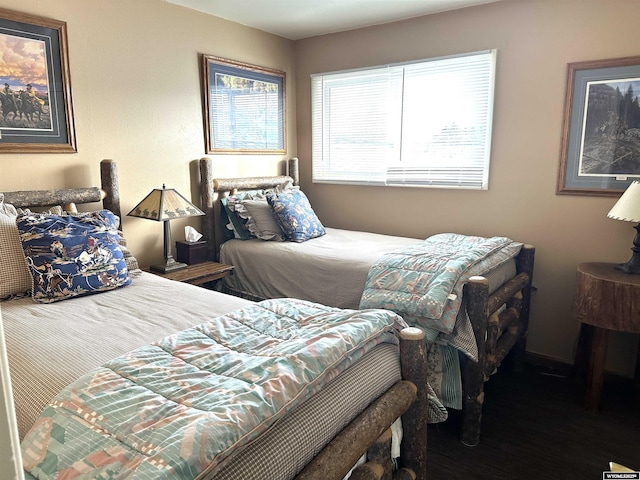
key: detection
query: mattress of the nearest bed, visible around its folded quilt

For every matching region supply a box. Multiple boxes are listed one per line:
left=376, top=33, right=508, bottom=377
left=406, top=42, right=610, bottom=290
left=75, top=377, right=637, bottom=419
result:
left=0, top=273, right=401, bottom=480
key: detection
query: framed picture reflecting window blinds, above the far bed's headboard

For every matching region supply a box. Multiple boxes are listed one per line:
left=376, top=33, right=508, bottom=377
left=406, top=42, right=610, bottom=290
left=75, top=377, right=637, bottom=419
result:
left=202, top=54, right=286, bottom=154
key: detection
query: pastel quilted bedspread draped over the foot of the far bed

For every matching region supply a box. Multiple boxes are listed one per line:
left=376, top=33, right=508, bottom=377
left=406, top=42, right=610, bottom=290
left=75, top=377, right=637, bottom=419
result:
left=360, top=233, right=521, bottom=409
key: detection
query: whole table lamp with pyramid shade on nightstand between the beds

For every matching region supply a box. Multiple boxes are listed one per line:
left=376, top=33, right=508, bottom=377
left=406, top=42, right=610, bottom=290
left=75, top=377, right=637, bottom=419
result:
left=127, top=184, right=204, bottom=273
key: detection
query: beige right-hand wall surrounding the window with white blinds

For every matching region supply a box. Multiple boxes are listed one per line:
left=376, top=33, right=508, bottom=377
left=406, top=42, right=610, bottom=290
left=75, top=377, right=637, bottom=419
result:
left=295, top=0, right=640, bottom=374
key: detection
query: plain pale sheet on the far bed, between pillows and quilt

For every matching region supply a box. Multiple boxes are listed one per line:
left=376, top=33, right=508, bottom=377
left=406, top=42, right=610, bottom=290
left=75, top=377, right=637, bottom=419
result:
left=220, top=228, right=422, bottom=308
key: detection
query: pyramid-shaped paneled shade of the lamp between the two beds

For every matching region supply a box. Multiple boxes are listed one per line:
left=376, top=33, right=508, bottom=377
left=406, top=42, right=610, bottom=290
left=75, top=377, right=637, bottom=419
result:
left=127, top=185, right=204, bottom=222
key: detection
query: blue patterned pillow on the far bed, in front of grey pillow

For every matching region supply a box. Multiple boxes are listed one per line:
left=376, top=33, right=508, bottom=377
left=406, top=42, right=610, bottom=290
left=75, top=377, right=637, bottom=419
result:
left=267, top=190, right=326, bottom=242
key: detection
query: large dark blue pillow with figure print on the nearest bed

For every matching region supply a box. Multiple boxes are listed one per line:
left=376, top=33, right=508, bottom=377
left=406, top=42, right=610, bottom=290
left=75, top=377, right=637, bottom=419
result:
left=16, top=210, right=131, bottom=303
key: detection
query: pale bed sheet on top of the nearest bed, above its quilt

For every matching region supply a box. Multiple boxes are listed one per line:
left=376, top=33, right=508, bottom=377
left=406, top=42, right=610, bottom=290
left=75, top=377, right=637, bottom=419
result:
left=0, top=273, right=251, bottom=438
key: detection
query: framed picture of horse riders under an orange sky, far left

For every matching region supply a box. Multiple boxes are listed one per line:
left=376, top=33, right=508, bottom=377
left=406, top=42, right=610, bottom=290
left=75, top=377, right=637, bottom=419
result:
left=0, top=8, right=77, bottom=153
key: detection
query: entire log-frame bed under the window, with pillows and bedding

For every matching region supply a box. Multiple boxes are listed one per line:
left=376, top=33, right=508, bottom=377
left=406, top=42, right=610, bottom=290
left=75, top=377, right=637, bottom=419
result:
left=200, top=157, right=535, bottom=445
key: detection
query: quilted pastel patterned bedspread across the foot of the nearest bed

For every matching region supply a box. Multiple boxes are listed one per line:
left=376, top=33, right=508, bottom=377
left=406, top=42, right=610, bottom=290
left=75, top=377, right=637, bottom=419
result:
left=22, top=299, right=406, bottom=480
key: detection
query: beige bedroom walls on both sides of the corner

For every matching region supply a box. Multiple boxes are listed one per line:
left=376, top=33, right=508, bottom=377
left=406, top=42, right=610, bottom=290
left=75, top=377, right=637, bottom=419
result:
left=0, top=0, right=640, bottom=374
